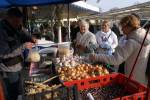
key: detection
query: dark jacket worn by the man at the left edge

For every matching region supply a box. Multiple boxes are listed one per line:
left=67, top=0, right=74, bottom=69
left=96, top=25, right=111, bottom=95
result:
left=0, top=20, right=32, bottom=59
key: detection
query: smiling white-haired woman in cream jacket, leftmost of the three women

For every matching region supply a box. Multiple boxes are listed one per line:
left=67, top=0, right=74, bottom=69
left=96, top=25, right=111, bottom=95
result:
left=75, top=20, right=97, bottom=54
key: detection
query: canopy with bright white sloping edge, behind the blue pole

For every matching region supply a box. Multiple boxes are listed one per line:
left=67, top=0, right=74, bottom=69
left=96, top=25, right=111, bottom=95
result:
left=29, top=1, right=99, bottom=19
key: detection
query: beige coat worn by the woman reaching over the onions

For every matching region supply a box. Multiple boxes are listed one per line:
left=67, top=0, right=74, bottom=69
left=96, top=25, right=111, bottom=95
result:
left=96, top=28, right=150, bottom=85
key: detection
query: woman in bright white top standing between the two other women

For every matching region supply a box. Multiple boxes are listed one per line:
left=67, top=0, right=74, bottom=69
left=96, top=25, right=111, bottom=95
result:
left=96, top=20, right=118, bottom=55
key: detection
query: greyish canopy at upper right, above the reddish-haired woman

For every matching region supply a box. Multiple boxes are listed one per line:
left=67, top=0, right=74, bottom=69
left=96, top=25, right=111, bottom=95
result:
left=79, top=1, right=150, bottom=19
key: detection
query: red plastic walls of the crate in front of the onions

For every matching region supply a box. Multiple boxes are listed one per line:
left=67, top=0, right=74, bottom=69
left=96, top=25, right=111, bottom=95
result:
left=64, top=73, right=146, bottom=100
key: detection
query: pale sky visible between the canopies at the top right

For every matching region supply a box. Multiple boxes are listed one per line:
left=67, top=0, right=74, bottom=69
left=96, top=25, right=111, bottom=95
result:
left=87, top=0, right=150, bottom=12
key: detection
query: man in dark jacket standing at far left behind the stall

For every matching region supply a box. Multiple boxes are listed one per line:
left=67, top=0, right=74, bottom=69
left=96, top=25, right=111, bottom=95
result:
left=0, top=8, right=36, bottom=100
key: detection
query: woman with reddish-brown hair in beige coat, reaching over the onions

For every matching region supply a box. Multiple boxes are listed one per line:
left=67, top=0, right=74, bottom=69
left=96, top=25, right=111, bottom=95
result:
left=89, top=15, right=150, bottom=85
